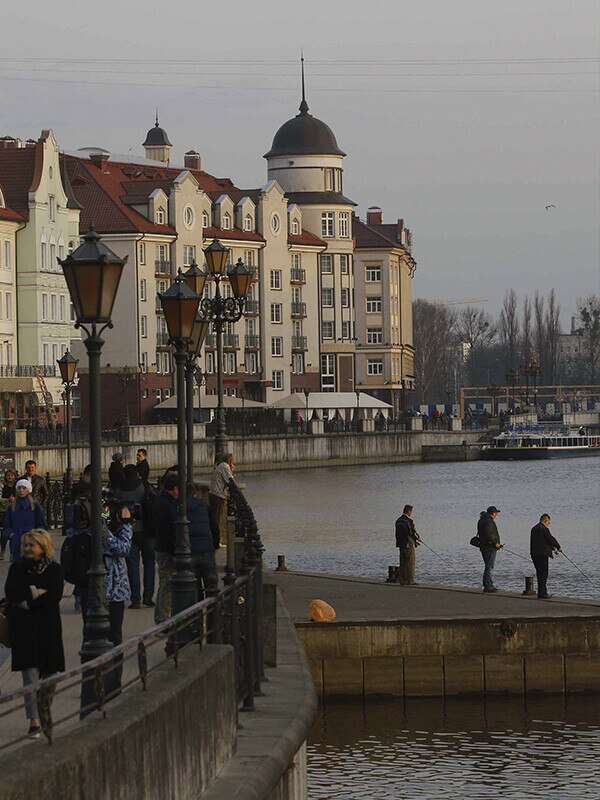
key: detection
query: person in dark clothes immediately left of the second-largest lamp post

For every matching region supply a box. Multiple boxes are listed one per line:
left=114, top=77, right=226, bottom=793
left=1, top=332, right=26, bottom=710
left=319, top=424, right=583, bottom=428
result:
left=154, top=472, right=179, bottom=625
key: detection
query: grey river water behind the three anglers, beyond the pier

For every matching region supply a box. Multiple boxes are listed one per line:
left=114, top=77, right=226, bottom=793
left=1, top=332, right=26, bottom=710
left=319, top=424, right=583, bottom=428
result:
left=243, top=458, right=600, bottom=599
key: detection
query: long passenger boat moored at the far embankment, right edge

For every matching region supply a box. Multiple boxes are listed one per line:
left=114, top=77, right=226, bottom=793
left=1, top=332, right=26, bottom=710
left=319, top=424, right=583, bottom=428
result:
left=479, top=426, right=600, bottom=461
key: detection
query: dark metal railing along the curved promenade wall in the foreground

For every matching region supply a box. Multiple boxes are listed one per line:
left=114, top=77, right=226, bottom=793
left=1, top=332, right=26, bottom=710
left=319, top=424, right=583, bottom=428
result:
left=0, top=482, right=263, bottom=751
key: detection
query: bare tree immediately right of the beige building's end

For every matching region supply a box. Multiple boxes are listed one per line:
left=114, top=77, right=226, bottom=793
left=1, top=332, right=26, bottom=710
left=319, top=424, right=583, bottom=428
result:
left=413, top=300, right=456, bottom=403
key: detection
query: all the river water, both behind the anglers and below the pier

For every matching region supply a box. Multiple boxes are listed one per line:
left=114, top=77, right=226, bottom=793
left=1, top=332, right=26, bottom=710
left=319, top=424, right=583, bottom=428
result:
left=243, top=458, right=600, bottom=800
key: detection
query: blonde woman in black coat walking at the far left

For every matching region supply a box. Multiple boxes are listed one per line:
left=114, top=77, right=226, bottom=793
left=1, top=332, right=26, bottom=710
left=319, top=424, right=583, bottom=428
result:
left=4, top=528, right=65, bottom=739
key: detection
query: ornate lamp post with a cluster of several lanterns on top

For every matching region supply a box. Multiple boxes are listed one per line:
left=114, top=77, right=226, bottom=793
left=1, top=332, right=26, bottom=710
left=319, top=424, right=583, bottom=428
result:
left=200, top=239, right=254, bottom=460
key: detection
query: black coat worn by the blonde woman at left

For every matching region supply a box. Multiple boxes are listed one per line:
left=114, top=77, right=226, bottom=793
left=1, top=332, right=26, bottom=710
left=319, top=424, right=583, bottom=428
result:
left=4, top=559, right=65, bottom=675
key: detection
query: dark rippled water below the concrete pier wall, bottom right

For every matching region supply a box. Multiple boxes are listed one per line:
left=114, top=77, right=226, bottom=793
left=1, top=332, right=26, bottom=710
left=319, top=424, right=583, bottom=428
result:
left=308, top=697, right=600, bottom=800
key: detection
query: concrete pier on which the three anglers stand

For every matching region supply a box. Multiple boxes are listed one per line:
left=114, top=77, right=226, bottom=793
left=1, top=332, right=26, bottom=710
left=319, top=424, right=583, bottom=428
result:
left=275, top=572, right=600, bottom=697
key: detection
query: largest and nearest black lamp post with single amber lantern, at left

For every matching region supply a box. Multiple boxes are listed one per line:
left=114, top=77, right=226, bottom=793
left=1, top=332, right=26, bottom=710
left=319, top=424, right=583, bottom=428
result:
left=58, top=228, right=127, bottom=668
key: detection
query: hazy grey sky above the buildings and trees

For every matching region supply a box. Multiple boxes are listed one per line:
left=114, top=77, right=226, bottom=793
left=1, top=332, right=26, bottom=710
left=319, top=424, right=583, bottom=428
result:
left=0, top=0, right=600, bottom=323
